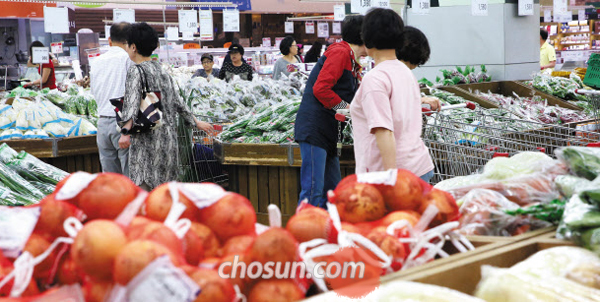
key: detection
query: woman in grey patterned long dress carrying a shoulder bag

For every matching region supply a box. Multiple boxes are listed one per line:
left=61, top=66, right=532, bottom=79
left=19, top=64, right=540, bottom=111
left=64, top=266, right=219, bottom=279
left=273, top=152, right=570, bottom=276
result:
left=119, top=23, right=212, bottom=190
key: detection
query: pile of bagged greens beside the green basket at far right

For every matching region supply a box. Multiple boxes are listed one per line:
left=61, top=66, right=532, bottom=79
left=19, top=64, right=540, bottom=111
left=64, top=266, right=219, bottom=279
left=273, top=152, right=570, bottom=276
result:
left=527, top=72, right=588, bottom=102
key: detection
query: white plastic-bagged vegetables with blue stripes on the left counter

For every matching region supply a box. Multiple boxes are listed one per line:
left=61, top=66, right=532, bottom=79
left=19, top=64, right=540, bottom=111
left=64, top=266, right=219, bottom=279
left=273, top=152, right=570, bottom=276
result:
left=0, top=98, right=97, bottom=140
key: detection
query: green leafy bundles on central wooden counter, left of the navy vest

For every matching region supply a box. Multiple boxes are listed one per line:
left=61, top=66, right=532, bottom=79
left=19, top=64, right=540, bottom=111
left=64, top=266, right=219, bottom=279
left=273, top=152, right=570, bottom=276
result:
left=220, top=101, right=300, bottom=144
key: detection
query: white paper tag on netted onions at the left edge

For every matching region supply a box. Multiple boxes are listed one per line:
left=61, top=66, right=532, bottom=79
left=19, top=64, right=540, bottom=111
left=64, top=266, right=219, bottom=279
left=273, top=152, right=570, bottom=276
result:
left=0, top=206, right=41, bottom=258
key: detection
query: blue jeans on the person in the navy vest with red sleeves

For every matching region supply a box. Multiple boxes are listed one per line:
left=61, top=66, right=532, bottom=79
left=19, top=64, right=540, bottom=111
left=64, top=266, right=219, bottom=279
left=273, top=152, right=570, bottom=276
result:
left=299, top=142, right=342, bottom=208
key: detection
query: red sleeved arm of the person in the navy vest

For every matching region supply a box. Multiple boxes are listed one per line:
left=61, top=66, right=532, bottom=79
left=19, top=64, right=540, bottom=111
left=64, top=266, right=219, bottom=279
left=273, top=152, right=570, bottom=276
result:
left=313, top=49, right=351, bottom=109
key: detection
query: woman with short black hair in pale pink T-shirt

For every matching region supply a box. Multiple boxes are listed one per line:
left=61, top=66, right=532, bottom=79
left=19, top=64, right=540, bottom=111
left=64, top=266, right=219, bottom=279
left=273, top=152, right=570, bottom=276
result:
left=350, top=8, right=433, bottom=181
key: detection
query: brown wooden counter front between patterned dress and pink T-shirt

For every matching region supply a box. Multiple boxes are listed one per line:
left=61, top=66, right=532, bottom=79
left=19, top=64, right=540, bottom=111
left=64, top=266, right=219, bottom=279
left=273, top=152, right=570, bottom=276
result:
left=214, top=140, right=354, bottom=224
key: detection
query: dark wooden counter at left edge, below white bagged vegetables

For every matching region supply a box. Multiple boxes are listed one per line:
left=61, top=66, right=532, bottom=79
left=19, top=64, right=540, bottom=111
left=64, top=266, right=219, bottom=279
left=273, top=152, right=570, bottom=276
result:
left=0, top=135, right=102, bottom=173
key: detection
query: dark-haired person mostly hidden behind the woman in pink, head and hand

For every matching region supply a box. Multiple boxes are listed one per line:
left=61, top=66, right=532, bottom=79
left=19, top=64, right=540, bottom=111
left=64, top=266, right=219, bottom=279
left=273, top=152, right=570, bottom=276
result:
left=396, top=26, right=441, bottom=110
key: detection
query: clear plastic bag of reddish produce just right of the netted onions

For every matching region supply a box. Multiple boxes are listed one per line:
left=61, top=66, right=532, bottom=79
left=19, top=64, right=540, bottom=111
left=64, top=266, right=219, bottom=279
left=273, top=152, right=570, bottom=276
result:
left=460, top=189, right=550, bottom=236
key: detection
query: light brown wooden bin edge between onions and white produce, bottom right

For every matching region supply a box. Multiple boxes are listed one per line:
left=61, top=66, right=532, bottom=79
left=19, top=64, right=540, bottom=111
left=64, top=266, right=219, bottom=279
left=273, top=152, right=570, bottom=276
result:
left=382, top=230, right=574, bottom=294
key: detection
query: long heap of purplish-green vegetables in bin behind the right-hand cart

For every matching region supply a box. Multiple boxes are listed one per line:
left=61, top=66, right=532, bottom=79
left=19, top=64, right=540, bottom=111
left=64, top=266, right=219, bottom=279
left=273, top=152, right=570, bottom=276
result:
left=475, top=91, right=591, bottom=124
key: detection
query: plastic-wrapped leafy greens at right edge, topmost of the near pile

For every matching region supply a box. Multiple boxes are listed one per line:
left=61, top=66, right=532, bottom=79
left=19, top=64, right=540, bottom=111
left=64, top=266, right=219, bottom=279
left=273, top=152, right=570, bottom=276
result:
left=556, top=147, right=600, bottom=180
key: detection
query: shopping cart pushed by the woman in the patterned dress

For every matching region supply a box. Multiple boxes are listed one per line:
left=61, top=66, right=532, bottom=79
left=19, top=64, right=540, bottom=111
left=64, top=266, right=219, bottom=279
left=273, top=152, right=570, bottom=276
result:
left=177, top=115, right=229, bottom=186
